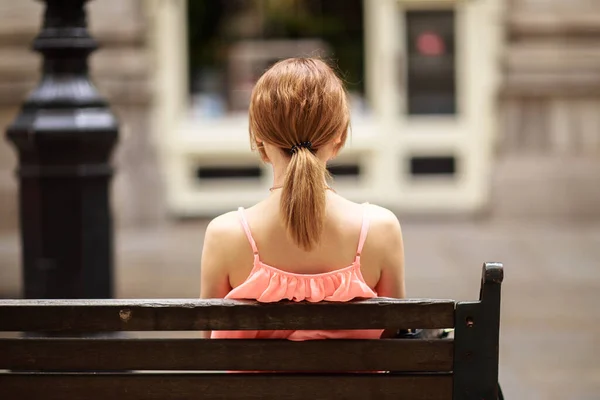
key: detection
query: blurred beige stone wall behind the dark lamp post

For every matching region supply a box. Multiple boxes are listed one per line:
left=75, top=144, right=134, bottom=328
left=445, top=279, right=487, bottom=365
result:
left=0, top=0, right=164, bottom=230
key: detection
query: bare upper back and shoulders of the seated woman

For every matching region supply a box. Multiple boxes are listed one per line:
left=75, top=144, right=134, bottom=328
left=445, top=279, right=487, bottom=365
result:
left=202, top=193, right=403, bottom=297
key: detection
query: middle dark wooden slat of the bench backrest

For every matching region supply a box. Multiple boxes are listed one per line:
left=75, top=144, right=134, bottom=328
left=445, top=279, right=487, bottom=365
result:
left=0, top=338, right=454, bottom=372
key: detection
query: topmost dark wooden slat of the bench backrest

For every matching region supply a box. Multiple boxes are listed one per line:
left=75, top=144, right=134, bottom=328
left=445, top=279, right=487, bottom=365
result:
left=0, top=298, right=455, bottom=332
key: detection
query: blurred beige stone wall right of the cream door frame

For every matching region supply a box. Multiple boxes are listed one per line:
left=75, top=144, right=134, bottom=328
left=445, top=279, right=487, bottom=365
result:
left=492, top=0, right=600, bottom=218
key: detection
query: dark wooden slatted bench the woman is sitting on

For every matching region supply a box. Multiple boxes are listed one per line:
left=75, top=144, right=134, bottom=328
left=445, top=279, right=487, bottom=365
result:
left=0, top=263, right=503, bottom=400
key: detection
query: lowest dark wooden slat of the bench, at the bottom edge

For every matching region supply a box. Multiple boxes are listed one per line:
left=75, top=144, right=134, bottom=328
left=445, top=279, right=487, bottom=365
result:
left=0, top=373, right=452, bottom=400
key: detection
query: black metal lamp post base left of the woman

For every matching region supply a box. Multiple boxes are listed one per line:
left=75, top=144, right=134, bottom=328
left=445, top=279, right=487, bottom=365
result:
left=6, top=0, right=118, bottom=298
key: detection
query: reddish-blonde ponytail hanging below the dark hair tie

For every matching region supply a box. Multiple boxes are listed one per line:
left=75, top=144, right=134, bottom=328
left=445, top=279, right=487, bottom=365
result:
left=280, top=148, right=328, bottom=251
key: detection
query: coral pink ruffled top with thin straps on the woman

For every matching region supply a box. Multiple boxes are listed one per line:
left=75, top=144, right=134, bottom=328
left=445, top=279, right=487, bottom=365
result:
left=211, top=204, right=382, bottom=340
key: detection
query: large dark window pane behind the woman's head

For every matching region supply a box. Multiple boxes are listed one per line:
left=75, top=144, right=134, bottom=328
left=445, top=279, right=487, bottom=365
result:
left=187, top=0, right=366, bottom=118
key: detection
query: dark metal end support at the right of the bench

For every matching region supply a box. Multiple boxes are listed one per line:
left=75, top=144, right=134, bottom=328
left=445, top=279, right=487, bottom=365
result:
left=453, top=263, right=504, bottom=400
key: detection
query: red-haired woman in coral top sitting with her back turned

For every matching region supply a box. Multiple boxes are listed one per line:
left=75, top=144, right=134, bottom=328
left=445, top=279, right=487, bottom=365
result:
left=201, top=58, right=405, bottom=340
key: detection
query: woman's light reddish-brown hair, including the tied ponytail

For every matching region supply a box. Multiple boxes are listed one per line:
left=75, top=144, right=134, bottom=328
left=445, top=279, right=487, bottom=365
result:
left=250, top=58, right=350, bottom=250
